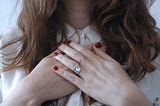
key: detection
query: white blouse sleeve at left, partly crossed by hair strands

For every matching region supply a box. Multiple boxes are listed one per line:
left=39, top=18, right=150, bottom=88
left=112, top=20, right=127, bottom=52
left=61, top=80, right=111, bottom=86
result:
left=0, top=28, right=26, bottom=102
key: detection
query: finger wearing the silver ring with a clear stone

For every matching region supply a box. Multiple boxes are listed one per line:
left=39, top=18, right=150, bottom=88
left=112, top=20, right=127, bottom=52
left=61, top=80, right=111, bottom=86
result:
left=54, top=54, right=86, bottom=78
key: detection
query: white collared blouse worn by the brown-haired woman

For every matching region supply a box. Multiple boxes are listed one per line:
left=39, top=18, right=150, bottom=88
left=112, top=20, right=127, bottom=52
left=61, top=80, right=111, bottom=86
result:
left=0, top=24, right=160, bottom=106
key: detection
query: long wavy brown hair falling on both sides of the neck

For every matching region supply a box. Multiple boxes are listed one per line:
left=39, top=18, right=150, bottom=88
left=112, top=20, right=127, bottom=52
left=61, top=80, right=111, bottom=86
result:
left=1, top=0, right=160, bottom=106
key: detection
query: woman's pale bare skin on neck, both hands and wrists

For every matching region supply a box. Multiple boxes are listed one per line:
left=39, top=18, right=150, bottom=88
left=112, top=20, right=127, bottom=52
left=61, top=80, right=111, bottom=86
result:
left=1, top=0, right=150, bottom=106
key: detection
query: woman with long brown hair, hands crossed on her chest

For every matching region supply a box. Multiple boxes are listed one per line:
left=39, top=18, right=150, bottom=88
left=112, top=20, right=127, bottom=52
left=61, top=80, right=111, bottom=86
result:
left=1, top=0, right=160, bottom=106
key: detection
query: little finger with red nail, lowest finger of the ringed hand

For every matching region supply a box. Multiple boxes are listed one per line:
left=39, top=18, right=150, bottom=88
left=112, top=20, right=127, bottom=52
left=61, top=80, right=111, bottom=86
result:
left=53, top=66, right=84, bottom=88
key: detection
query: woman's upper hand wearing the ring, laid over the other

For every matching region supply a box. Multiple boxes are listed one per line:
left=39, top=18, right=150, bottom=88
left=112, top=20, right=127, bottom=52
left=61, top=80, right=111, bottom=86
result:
left=53, top=42, right=149, bottom=106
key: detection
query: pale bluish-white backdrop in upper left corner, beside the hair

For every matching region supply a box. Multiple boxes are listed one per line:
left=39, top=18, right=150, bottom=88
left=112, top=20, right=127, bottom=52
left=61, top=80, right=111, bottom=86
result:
left=0, top=0, right=23, bottom=35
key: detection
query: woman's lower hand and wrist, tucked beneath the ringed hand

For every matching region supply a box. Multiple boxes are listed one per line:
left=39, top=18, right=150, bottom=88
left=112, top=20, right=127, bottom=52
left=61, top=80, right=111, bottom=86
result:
left=0, top=50, right=77, bottom=106
